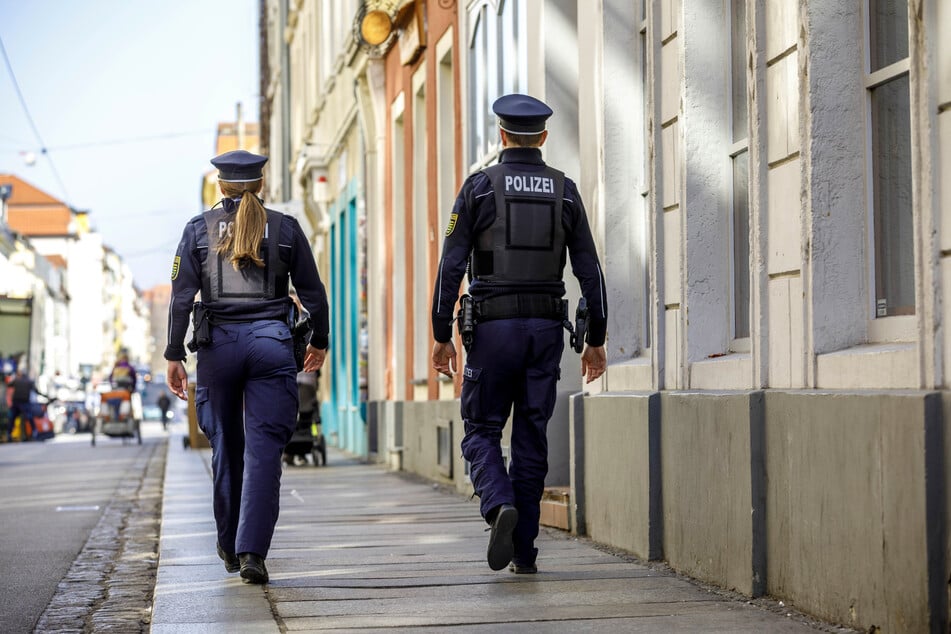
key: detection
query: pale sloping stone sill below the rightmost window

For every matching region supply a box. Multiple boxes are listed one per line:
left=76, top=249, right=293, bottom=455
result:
left=816, top=343, right=920, bottom=390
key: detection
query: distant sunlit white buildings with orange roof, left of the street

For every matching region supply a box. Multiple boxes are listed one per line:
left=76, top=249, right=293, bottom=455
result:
left=0, top=174, right=154, bottom=382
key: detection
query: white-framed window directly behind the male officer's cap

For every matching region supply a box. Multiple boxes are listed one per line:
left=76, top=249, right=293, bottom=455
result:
left=468, top=0, right=526, bottom=169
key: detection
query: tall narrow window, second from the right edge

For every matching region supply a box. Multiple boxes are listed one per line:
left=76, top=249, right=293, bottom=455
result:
left=730, top=0, right=750, bottom=350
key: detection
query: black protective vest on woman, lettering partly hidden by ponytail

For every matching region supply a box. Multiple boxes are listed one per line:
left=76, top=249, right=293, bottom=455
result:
left=201, top=202, right=287, bottom=303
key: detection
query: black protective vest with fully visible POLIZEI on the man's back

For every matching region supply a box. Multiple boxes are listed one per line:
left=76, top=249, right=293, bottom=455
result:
left=471, top=163, right=565, bottom=282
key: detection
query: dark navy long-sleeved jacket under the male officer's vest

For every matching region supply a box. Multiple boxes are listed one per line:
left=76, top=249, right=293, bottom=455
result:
left=432, top=148, right=607, bottom=346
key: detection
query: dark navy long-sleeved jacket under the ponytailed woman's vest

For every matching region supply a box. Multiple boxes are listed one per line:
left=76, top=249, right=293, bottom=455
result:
left=165, top=198, right=330, bottom=361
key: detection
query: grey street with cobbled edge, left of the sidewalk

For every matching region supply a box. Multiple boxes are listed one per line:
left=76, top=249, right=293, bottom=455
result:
left=0, top=422, right=166, bottom=633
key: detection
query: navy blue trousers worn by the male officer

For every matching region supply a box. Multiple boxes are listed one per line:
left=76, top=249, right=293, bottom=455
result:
left=462, top=318, right=565, bottom=563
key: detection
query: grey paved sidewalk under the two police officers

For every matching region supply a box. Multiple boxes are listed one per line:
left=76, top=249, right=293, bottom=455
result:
left=152, top=437, right=845, bottom=634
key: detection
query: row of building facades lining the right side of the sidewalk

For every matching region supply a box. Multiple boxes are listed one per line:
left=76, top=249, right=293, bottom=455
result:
left=269, top=0, right=951, bottom=631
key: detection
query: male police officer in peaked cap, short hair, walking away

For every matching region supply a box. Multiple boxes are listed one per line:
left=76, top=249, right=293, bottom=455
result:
left=432, top=94, right=607, bottom=573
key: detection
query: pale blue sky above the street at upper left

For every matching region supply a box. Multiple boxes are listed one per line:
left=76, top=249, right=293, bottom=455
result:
left=0, top=0, right=259, bottom=290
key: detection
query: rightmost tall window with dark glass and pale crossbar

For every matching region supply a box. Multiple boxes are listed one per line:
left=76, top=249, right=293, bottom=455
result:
left=865, top=0, right=915, bottom=317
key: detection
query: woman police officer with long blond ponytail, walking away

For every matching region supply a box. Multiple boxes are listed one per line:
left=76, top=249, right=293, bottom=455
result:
left=165, top=150, right=329, bottom=583
